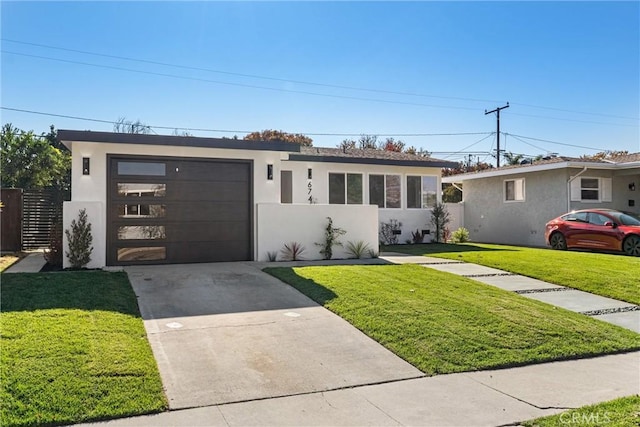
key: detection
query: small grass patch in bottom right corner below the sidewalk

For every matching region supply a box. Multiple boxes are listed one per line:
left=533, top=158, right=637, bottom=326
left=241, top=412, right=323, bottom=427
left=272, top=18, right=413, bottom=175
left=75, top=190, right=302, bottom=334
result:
left=522, top=395, right=640, bottom=427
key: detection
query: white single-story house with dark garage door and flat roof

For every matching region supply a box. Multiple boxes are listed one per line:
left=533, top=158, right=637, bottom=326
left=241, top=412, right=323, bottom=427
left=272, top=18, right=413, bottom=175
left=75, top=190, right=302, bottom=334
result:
left=58, top=130, right=456, bottom=267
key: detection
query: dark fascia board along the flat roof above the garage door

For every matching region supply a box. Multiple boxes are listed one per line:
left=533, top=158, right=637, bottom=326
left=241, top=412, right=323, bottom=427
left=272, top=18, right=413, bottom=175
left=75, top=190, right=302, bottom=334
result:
left=58, top=129, right=300, bottom=153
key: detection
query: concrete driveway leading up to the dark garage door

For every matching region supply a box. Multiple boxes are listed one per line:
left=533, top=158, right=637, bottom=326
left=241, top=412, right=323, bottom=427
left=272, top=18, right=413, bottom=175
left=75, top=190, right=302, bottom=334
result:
left=125, top=263, right=424, bottom=409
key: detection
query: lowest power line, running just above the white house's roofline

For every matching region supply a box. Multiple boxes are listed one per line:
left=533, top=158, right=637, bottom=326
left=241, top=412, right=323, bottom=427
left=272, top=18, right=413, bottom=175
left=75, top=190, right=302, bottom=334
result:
left=0, top=107, right=493, bottom=137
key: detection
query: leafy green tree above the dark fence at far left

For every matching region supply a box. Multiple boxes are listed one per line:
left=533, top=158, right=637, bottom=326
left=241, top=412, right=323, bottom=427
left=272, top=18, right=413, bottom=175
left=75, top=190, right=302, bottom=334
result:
left=0, top=123, right=71, bottom=189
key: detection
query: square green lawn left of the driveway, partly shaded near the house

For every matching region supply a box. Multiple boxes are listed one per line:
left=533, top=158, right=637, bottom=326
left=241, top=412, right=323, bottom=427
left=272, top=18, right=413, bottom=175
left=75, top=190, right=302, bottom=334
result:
left=0, top=271, right=167, bottom=426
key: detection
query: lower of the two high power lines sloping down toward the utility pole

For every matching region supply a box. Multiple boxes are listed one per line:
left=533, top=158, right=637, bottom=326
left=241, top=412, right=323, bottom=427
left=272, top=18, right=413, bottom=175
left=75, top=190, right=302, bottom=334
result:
left=0, top=50, right=477, bottom=111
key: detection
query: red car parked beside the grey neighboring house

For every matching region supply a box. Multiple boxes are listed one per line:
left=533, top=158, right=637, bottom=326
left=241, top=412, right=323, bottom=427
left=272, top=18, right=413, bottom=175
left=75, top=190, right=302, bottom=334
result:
left=544, top=209, right=640, bottom=256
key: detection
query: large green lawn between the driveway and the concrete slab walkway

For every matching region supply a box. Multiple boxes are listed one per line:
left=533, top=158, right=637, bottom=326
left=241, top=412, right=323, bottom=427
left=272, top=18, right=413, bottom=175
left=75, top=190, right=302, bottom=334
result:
left=265, top=265, right=640, bottom=375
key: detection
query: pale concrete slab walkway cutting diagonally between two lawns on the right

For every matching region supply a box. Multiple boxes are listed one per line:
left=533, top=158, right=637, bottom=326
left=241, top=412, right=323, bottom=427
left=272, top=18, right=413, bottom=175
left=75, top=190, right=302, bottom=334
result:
left=380, top=252, right=640, bottom=333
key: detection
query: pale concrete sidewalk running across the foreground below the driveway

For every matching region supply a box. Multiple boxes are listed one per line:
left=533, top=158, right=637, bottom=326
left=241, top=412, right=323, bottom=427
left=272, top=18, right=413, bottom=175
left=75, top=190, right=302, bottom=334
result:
left=77, top=352, right=640, bottom=427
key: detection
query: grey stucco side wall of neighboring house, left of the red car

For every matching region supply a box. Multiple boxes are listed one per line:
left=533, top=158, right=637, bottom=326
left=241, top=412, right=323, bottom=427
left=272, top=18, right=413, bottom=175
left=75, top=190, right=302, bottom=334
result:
left=463, top=170, right=567, bottom=246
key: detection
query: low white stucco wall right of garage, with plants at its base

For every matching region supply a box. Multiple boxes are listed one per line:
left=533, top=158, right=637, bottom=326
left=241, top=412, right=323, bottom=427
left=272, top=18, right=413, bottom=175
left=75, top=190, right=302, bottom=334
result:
left=256, top=203, right=378, bottom=261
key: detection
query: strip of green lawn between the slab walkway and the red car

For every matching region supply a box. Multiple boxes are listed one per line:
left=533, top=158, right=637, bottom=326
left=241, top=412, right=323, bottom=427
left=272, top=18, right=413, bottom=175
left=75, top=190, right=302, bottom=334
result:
left=385, top=243, right=640, bottom=304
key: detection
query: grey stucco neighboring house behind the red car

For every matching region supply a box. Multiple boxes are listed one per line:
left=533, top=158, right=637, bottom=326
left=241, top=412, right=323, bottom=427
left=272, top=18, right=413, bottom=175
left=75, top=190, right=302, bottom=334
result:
left=442, top=153, right=640, bottom=246
